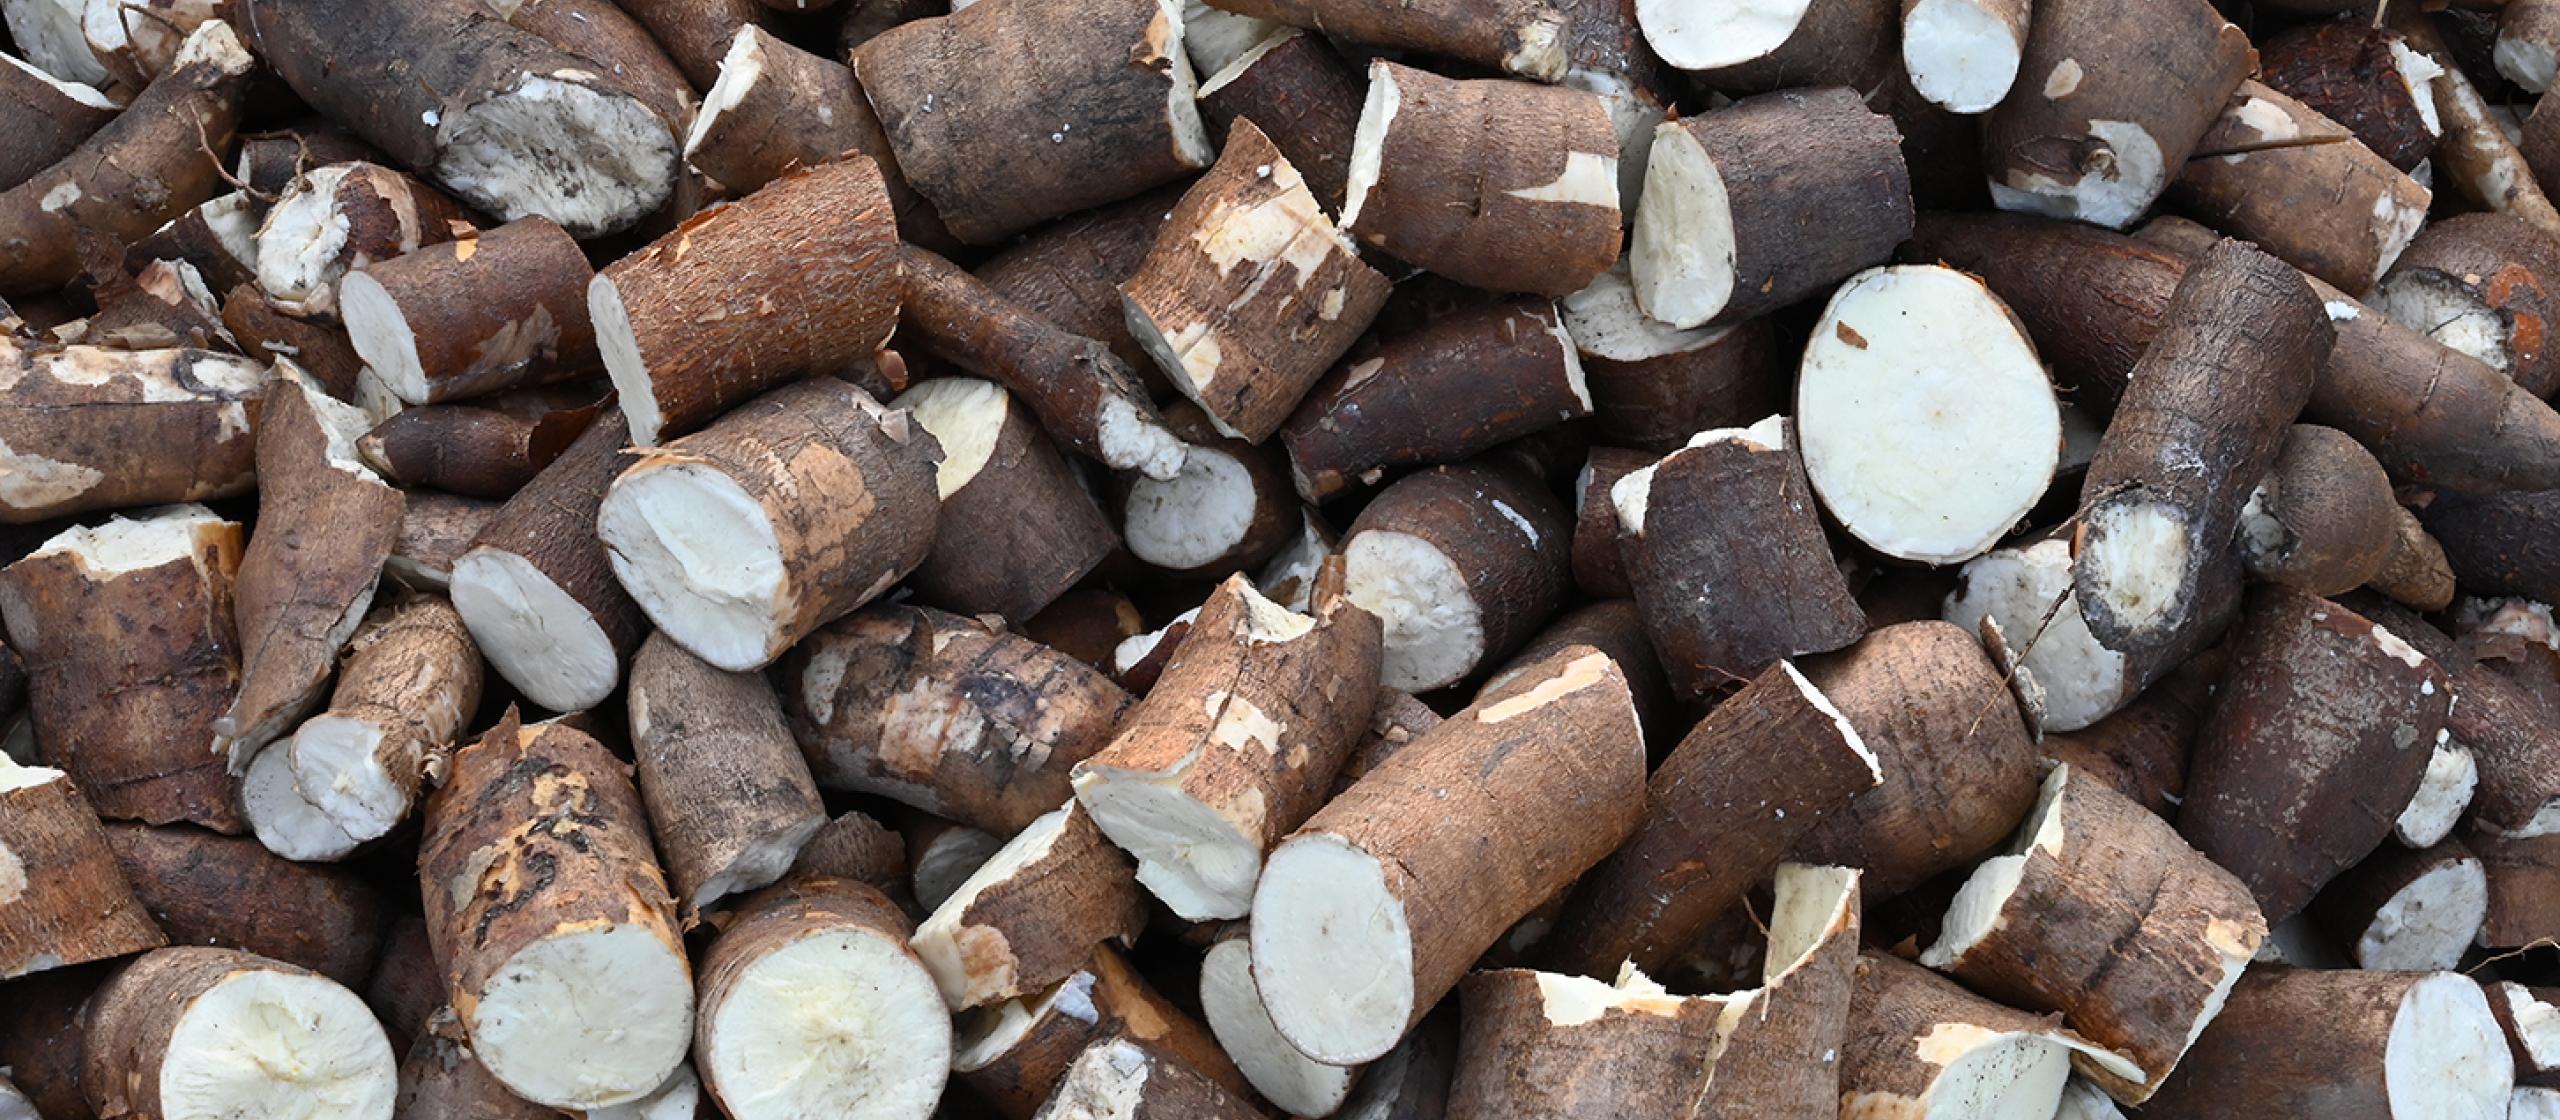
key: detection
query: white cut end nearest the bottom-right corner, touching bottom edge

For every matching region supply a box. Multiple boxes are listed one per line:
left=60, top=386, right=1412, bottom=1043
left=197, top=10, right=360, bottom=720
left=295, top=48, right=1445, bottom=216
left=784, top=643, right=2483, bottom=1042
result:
left=2383, top=972, right=2516, bottom=1120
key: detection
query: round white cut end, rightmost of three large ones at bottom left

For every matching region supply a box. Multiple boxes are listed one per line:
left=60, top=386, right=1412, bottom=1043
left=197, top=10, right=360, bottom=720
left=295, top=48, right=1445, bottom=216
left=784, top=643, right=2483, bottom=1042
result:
left=701, top=928, right=952, bottom=1120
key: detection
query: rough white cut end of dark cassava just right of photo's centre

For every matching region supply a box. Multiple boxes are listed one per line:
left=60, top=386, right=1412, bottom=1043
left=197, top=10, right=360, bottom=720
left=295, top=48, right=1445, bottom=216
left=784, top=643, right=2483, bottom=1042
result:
left=1341, top=529, right=1485, bottom=693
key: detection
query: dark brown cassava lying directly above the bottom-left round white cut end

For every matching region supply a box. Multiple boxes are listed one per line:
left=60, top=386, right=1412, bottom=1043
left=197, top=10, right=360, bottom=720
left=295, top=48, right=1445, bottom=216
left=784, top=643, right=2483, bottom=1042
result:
left=108, top=823, right=381, bottom=987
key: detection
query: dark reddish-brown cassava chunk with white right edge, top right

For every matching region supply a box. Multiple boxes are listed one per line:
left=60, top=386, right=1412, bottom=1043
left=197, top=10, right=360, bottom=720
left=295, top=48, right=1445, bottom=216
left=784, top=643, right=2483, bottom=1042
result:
left=2258, top=20, right=2435, bottom=171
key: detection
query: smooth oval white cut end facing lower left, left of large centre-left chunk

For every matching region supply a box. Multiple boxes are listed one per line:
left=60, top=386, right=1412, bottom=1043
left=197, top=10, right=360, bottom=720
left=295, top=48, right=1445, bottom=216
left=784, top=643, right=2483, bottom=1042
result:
left=448, top=547, right=622, bottom=711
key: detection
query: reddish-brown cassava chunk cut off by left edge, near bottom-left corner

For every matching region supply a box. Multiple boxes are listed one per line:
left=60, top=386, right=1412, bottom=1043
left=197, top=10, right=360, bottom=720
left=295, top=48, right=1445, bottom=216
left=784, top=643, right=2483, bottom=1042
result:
left=0, top=757, right=169, bottom=981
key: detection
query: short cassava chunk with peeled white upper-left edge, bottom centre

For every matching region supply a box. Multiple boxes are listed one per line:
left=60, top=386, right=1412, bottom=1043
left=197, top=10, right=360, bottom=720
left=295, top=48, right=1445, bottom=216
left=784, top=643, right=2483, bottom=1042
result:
left=914, top=803, right=1147, bottom=1010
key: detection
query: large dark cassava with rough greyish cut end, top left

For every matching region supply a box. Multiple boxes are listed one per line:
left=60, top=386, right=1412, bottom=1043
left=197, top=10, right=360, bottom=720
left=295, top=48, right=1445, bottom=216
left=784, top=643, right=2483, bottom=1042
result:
left=241, top=0, right=678, bottom=238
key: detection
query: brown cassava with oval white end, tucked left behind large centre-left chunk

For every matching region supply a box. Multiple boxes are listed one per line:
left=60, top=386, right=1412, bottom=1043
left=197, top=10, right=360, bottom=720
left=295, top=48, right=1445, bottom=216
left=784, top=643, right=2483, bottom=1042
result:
left=451, top=409, right=648, bottom=711
